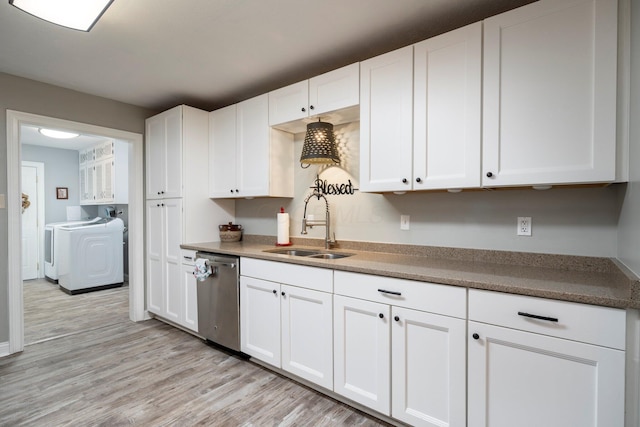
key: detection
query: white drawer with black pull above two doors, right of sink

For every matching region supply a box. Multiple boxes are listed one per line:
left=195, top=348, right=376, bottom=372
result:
left=334, top=271, right=467, bottom=319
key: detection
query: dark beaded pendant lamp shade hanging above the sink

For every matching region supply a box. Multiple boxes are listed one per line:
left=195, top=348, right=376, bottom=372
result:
left=300, top=120, right=340, bottom=168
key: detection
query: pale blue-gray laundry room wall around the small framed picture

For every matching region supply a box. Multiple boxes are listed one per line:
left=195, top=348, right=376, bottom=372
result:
left=21, top=144, right=80, bottom=224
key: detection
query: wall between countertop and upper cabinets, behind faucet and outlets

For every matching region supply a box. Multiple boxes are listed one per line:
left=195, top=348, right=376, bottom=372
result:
left=236, top=123, right=625, bottom=257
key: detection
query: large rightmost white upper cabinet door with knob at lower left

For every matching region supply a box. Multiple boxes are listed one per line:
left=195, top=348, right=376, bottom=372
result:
left=482, top=0, right=617, bottom=186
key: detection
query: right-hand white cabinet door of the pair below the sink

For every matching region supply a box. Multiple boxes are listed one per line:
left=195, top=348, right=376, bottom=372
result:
left=280, top=285, right=333, bottom=390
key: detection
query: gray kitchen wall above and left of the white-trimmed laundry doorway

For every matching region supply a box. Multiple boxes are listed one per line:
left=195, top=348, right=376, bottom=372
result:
left=0, top=73, right=156, bottom=348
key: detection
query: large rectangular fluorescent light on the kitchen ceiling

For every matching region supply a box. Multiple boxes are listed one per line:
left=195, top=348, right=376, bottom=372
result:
left=9, top=0, right=113, bottom=31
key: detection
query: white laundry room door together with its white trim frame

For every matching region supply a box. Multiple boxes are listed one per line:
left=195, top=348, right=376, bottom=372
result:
left=20, top=161, right=44, bottom=280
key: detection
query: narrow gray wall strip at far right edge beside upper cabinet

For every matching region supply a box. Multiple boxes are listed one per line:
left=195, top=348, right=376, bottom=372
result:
left=618, top=0, right=640, bottom=275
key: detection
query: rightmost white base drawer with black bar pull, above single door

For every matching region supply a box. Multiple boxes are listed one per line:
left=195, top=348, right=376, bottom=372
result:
left=469, top=289, right=626, bottom=350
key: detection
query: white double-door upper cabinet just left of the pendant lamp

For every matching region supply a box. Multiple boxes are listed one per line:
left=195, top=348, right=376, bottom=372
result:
left=209, top=94, right=294, bottom=198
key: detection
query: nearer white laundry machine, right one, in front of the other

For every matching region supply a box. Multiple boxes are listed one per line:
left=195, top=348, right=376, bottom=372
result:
left=57, top=218, right=124, bottom=294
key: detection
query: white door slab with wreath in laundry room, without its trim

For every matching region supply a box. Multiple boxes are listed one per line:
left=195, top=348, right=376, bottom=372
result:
left=22, top=164, right=40, bottom=280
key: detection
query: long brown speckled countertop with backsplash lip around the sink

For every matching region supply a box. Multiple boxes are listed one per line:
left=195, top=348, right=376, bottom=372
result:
left=182, top=235, right=640, bottom=308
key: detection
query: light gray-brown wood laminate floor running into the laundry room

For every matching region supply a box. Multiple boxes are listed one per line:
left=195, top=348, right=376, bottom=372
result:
left=0, top=283, right=387, bottom=426
